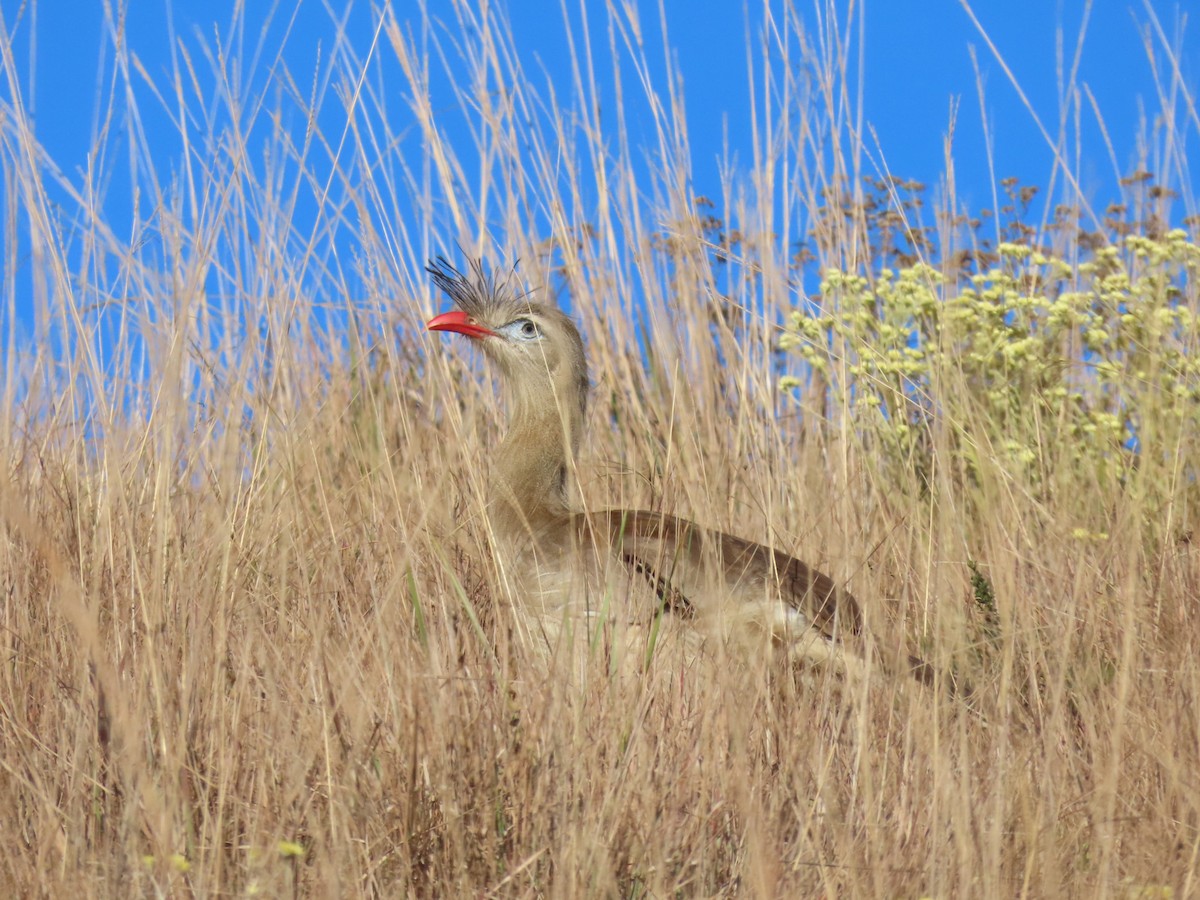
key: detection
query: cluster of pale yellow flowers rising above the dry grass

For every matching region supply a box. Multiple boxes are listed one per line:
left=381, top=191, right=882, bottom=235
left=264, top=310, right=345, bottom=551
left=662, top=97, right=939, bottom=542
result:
left=780, top=230, right=1200, bottom=487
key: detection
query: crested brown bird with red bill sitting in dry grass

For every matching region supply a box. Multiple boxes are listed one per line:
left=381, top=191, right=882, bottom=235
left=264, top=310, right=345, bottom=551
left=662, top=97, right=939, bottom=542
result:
left=426, top=256, right=934, bottom=684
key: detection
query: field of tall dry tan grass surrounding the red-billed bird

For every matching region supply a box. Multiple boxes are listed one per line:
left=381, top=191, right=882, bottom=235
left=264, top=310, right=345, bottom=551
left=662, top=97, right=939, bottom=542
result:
left=0, top=8, right=1200, bottom=900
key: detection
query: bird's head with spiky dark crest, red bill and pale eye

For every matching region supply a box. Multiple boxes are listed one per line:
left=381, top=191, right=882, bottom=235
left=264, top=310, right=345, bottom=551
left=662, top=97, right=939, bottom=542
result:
left=426, top=258, right=588, bottom=414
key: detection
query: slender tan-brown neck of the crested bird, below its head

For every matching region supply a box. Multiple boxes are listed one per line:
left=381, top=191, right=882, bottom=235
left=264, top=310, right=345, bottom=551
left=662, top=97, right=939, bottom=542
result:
left=492, top=390, right=583, bottom=538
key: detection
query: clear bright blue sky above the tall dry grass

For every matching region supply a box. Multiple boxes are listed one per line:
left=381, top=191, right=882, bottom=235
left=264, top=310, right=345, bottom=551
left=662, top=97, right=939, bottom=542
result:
left=0, top=0, right=1200, bottom=346
